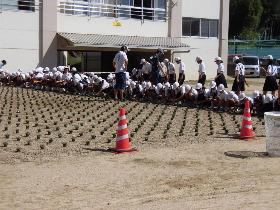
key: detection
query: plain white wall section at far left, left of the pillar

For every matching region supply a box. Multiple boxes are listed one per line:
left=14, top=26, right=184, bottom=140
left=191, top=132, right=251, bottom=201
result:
left=0, top=11, right=39, bottom=71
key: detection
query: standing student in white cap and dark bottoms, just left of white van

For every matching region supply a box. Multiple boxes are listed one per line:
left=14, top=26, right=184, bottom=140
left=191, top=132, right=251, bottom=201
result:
left=232, top=56, right=245, bottom=95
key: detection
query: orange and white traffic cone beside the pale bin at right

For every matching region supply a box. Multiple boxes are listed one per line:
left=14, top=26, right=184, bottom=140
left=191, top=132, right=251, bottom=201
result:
left=240, top=99, right=255, bottom=139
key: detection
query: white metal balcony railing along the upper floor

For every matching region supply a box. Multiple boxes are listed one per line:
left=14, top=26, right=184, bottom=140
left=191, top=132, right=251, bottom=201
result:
left=59, top=0, right=167, bottom=21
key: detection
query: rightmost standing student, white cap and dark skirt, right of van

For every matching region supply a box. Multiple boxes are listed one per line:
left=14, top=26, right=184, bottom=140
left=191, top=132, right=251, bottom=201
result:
left=262, top=55, right=278, bottom=96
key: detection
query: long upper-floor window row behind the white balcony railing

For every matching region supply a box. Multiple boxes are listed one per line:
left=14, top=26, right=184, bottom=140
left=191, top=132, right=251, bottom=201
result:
left=59, top=0, right=167, bottom=21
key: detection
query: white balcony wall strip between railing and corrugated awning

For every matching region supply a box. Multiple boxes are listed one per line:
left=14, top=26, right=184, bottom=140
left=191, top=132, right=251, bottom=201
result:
left=57, top=13, right=168, bottom=37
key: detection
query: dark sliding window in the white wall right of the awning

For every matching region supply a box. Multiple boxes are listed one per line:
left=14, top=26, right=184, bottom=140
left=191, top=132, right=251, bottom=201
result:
left=182, top=17, right=219, bottom=37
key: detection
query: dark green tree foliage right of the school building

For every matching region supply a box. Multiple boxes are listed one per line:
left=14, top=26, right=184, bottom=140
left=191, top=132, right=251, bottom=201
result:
left=229, top=0, right=280, bottom=39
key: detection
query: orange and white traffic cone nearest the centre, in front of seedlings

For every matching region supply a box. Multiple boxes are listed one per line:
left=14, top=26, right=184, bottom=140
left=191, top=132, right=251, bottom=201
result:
left=111, top=108, right=137, bottom=153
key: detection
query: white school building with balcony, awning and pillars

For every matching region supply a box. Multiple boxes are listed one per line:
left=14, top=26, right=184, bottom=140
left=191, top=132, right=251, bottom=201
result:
left=0, top=0, right=229, bottom=80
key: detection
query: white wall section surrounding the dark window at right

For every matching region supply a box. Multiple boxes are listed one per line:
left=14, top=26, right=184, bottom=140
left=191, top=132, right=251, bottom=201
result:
left=172, top=0, right=220, bottom=80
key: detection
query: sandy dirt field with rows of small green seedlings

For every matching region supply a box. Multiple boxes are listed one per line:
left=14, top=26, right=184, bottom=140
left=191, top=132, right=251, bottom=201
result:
left=0, top=81, right=280, bottom=209
